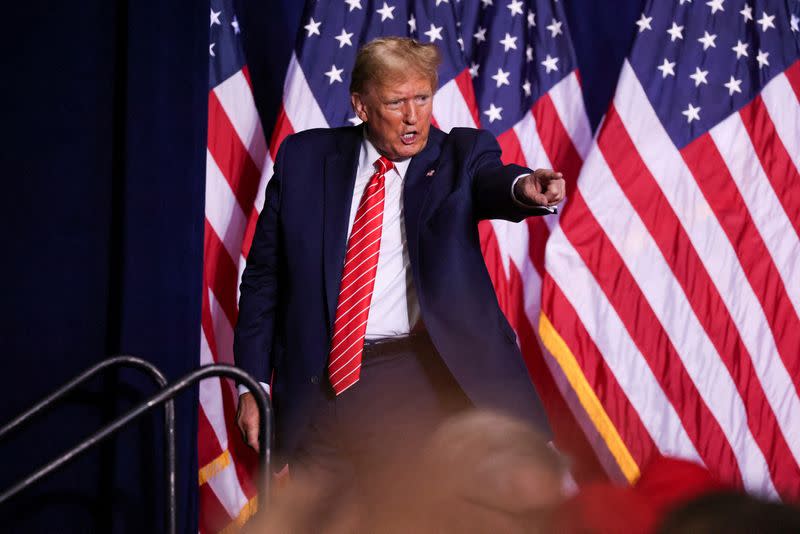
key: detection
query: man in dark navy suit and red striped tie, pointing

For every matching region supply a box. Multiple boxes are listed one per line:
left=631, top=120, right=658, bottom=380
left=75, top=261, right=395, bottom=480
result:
left=234, top=38, right=564, bottom=532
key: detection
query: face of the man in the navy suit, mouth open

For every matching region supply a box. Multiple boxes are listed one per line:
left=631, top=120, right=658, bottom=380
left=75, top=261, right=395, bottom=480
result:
left=351, top=76, right=433, bottom=161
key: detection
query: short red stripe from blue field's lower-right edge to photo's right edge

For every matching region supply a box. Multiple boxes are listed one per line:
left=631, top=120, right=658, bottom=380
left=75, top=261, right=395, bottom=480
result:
left=739, top=95, right=800, bottom=236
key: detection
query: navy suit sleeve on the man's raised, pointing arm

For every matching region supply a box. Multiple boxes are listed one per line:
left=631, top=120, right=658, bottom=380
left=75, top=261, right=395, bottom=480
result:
left=468, top=130, right=550, bottom=222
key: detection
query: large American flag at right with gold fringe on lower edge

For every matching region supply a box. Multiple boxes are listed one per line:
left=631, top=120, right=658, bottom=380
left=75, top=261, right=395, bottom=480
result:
left=540, top=0, right=800, bottom=499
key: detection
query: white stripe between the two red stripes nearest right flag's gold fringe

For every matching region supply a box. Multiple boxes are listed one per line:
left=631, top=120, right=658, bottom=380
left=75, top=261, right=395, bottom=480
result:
left=545, top=220, right=703, bottom=465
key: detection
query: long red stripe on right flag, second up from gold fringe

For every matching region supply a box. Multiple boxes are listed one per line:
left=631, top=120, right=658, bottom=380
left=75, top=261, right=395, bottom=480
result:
left=561, top=191, right=742, bottom=486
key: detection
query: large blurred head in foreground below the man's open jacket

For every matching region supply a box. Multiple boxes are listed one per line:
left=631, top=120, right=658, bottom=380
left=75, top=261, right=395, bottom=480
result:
left=400, top=411, right=566, bottom=534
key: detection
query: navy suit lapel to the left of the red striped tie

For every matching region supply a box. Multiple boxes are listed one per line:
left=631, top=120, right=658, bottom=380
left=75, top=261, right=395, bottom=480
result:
left=323, top=127, right=363, bottom=336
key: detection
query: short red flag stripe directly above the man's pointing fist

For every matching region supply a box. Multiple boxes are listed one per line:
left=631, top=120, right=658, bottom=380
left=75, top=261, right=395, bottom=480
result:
left=531, top=93, right=583, bottom=197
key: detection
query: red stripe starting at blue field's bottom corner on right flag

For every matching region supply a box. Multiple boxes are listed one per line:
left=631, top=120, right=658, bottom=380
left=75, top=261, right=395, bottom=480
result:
left=681, top=133, right=800, bottom=400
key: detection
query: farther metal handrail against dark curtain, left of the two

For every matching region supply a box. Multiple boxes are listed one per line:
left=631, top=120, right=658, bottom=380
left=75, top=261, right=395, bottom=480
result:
left=0, top=355, right=177, bottom=534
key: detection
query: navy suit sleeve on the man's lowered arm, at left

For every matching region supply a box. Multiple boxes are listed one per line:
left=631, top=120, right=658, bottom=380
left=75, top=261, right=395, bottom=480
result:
left=233, top=139, right=288, bottom=383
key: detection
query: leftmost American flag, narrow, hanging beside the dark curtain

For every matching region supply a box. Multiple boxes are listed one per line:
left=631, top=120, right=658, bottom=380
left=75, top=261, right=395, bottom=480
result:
left=197, top=0, right=271, bottom=533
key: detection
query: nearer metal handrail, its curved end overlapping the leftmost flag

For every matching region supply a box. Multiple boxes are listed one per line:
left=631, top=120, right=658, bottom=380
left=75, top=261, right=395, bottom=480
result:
left=0, top=364, right=272, bottom=525
